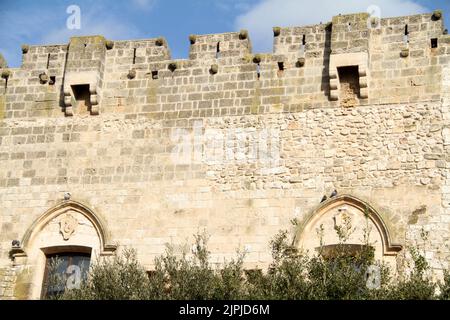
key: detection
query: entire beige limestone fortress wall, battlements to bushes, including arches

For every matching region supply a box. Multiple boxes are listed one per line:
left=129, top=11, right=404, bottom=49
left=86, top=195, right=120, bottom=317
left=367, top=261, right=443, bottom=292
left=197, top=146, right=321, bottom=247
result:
left=0, top=11, right=450, bottom=299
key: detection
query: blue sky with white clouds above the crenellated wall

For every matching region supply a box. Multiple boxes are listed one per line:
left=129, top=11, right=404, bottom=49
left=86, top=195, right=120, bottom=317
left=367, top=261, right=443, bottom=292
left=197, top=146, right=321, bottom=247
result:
left=0, top=0, right=450, bottom=67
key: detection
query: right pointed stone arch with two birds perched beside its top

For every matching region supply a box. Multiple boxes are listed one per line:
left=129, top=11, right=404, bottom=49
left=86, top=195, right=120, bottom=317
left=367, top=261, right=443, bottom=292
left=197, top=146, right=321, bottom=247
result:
left=294, top=194, right=402, bottom=258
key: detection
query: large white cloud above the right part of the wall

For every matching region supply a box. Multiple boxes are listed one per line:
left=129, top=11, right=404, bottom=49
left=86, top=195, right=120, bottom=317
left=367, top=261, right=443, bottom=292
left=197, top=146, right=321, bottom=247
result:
left=235, top=0, right=430, bottom=52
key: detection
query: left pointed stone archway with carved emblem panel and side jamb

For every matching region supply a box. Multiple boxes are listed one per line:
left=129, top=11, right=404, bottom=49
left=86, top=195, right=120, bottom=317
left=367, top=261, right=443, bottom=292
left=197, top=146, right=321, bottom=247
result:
left=11, top=200, right=116, bottom=299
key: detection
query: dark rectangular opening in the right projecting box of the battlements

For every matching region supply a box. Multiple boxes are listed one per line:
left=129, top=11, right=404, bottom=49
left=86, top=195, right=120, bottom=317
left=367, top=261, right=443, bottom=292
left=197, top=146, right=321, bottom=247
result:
left=337, top=66, right=359, bottom=107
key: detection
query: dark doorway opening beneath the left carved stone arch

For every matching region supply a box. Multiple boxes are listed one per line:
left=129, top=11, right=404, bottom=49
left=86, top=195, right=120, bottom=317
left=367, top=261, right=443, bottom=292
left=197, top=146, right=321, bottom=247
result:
left=41, top=252, right=91, bottom=299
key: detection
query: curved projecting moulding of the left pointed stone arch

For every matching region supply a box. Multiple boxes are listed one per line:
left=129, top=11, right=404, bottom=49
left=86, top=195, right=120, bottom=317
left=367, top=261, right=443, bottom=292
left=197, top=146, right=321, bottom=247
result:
left=11, top=200, right=117, bottom=257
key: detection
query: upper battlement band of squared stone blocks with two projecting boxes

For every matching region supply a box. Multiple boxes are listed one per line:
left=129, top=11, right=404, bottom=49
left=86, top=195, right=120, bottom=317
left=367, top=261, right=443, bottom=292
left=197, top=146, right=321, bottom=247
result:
left=0, top=11, right=450, bottom=118
